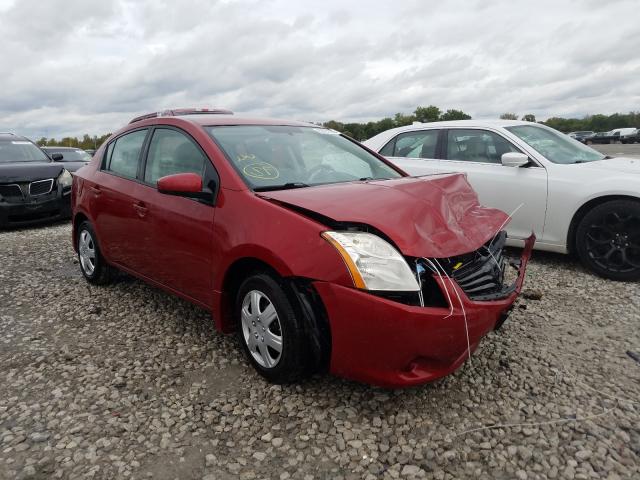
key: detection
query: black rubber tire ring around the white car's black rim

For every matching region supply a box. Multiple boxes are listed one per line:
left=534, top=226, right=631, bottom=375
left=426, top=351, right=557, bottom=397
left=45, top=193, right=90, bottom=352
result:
left=576, top=200, right=640, bottom=281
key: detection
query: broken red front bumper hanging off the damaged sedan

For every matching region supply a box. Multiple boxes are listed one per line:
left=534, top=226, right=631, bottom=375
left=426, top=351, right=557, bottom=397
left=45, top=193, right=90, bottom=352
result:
left=314, top=236, right=535, bottom=388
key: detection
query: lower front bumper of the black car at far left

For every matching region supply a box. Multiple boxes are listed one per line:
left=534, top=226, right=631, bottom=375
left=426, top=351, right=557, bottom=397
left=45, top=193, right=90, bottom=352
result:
left=0, top=190, right=71, bottom=227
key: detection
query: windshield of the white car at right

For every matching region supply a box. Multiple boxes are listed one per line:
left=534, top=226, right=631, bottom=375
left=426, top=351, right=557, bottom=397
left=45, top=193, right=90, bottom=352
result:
left=505, top=125, right=605, bottom=164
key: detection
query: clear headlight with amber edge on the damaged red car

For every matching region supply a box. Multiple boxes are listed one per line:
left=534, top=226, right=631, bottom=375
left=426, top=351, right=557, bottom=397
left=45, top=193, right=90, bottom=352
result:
left=322, top=232, right=420, bottom=292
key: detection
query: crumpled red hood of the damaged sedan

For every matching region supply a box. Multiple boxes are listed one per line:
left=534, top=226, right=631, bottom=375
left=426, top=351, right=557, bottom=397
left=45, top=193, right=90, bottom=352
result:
left=258, top=174, right=508, bottom=258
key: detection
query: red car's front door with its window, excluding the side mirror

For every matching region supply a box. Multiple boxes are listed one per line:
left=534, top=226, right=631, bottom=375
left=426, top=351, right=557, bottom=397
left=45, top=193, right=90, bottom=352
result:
left=140, top=126, right=219, bottom=305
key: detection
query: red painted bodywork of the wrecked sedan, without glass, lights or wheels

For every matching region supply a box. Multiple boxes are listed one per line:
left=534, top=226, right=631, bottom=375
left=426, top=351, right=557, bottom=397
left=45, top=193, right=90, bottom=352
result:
left=72, top=116, right=530, bottom=386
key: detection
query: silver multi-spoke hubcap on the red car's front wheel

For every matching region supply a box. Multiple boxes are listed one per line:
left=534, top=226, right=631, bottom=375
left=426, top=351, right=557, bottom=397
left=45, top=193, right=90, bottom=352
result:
left=241, top=290, right=282, bottom=368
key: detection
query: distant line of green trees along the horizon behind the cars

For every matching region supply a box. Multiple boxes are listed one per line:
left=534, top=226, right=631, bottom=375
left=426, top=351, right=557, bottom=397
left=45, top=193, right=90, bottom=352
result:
left=37, top=105, right=640, bottom=150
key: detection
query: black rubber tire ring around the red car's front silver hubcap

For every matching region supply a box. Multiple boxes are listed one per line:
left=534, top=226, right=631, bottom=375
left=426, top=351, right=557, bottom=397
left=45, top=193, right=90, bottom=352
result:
left=234, top=273, right=308, bottom=384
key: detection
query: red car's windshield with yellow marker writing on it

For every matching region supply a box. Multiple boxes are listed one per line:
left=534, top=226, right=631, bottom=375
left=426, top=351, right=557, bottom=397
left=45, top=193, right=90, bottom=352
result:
left=205, top=125, right=402, bottom=190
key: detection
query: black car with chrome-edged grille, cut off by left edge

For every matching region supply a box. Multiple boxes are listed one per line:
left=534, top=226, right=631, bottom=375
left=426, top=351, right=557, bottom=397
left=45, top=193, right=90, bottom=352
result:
left=0, top=133, right=72, bottom=228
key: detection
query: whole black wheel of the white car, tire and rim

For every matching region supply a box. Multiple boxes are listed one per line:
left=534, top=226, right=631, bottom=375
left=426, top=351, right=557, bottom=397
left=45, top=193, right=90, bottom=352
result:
left=576, top=200, right=640, bottom=281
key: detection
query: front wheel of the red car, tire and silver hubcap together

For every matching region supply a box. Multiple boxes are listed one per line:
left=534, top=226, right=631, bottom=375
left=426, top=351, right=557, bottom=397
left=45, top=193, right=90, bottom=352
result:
left=234, top=273, right=312, bottom=384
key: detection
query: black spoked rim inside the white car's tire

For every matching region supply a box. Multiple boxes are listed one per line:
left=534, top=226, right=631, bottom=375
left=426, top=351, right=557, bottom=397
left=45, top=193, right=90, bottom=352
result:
left=586, top=211, right=640, bottom=273
